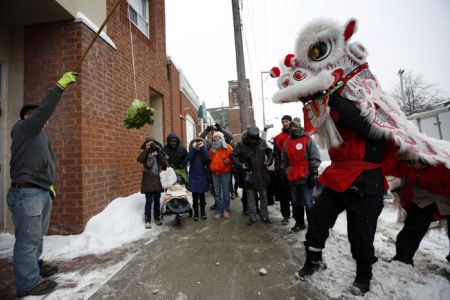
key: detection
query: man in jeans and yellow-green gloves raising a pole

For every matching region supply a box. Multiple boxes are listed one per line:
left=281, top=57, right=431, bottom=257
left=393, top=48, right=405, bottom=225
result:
left=7, top=72, right=78, bottom=297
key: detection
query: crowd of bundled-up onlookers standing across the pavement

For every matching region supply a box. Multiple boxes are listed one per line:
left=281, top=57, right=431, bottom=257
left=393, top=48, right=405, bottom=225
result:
left=137, top=115, right=320, bottom=232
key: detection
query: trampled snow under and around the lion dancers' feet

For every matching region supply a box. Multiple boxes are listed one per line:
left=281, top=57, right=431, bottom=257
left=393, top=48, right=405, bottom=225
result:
left=299, top=199, right=450, bottom=300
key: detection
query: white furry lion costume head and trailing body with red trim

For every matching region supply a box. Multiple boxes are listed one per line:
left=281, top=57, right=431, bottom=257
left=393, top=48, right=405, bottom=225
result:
left=271, top=18, right=450, bottom=168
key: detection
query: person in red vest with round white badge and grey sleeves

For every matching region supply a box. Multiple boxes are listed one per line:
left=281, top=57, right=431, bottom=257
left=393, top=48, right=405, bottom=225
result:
left=281, top=118, right=320, bottom=232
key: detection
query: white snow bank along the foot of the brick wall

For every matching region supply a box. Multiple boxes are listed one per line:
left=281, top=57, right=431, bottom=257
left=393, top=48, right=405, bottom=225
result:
left=0, top=193, right=168, bottom=299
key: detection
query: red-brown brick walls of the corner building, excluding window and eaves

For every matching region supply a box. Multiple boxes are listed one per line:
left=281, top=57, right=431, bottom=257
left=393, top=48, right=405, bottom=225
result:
left=24, top=0, right=172, bottom=233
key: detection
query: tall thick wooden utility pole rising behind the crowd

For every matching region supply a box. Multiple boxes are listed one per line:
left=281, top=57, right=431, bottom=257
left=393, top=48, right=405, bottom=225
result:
left=231, top=0, right=248, bottom=132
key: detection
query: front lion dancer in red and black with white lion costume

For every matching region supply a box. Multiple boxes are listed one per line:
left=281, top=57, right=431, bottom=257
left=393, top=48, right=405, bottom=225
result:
left=271, top=18, right=450, bottom=295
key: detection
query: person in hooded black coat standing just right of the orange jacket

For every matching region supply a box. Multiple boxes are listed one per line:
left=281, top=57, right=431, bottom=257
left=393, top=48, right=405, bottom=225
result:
left=231, top=125, right=273, bottom=225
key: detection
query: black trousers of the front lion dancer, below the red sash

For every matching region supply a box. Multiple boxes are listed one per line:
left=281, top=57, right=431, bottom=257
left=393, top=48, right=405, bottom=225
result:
left=305, top=187, right=383, bottom=264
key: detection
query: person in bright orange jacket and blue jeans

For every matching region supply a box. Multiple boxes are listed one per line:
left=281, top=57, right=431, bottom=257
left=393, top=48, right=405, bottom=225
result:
left=209, top=131, right=233, bottom=219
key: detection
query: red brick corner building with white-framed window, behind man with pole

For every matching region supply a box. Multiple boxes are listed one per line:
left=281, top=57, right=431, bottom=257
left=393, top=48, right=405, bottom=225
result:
left=0, top=0, right=204, bottom=234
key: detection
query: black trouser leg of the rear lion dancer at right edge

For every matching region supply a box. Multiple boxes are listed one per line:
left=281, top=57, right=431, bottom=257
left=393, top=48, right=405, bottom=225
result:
left=395, top=203, right=437, bottom=259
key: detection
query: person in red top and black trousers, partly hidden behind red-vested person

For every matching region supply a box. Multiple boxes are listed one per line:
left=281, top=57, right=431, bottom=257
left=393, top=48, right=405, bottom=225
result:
left=273, top=115, right=294, bottom=225
